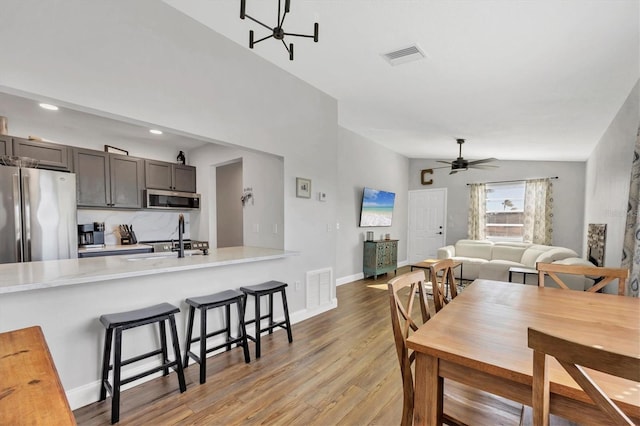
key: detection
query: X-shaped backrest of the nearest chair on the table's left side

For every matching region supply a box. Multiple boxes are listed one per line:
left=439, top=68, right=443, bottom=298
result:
left=387, top=269, right=430, bottom=426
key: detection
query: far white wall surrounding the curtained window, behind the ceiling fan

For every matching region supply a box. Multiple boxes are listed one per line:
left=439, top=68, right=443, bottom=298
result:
left=409, top=160, right=585, bottom=253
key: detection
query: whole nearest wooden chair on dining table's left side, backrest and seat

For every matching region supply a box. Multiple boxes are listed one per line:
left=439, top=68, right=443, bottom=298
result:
left=387, top=270, right=522, bottom=426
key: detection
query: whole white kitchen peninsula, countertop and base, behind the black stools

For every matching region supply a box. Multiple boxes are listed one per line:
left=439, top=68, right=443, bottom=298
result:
left=0, top=247, right=312, bottom=412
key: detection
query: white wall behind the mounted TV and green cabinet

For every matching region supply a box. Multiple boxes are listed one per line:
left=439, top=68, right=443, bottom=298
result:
left=336, top=128, right=409, bottom=284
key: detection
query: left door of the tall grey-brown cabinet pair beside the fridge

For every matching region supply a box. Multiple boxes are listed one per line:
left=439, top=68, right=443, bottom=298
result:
left=73, top=148, right=111, bottom=207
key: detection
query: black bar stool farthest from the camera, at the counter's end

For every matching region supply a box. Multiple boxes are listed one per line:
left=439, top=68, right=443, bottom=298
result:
left=240, top=281, right=293, bottom=358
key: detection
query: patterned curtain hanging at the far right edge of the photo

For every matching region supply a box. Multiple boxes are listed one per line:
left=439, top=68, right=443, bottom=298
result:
left=622, top=129, right=640, bottom=297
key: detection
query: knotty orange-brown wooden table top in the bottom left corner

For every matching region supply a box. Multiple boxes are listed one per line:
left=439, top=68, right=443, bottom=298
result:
left=0, top=327, right=76, bottom=425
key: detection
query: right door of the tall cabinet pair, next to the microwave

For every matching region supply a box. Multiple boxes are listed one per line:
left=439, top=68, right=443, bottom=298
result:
left=109, top=154, right=144, bottom=209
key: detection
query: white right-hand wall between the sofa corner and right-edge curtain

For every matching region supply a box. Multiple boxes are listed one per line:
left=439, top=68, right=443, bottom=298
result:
left=584, top=83, right=640, bottom=267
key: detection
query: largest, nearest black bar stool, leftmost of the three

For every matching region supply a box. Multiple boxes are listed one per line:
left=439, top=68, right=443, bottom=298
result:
left=100, top=303, right=187, bottom=424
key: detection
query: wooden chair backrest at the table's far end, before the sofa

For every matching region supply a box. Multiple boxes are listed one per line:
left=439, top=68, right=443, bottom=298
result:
left=536, top=262, right=629, bottom=296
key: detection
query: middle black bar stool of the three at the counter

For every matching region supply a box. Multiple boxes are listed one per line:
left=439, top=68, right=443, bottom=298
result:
left=184, top=290, right=251, bottom=384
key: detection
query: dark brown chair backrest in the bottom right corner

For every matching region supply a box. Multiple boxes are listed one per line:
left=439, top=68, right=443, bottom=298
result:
left=528, top=328, right=640, bottom=425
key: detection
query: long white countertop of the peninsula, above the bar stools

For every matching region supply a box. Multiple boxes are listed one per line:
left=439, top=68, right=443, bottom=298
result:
left=0, top=247, right=299, bottom=294
